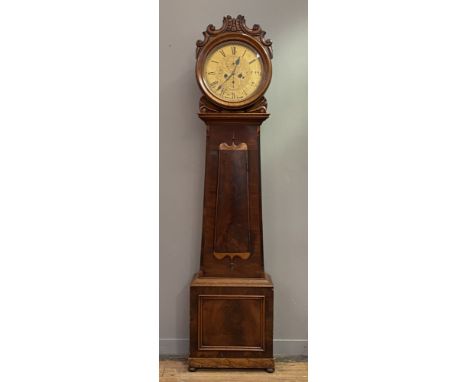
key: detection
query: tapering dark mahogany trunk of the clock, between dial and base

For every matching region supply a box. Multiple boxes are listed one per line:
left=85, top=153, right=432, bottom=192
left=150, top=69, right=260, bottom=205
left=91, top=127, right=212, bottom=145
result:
left=200, top=113, right=268, bottom=278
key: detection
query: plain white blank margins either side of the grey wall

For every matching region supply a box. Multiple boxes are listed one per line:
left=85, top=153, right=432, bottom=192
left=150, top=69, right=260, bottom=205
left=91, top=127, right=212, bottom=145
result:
left=0, top=0, right=468, bottom=382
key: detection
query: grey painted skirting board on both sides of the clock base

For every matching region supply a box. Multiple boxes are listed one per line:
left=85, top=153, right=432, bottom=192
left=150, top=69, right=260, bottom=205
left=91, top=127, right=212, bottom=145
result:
left=159, top=338, right=307, bottom=357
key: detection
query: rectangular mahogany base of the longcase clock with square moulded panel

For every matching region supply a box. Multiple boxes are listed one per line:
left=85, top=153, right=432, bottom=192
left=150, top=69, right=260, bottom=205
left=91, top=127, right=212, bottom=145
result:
left=188, top=274, right=274, bottom=370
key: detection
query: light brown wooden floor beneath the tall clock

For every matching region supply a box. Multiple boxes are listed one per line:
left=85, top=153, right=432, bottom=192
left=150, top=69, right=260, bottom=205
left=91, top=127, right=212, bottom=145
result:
left=159, top=359, right=307, bottom=382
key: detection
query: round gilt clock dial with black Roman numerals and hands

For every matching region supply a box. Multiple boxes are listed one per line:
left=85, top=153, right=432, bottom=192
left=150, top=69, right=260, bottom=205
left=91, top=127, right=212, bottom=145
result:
left=203, top=42, right=263, bottom=102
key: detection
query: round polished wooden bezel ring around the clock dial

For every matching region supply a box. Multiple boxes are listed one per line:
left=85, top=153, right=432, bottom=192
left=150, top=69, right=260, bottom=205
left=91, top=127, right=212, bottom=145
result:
left=195, top=32, right=272, bottom=109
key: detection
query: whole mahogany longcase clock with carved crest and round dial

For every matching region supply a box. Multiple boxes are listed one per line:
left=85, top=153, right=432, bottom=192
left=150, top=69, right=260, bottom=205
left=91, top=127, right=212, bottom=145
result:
left=188, top=15, right=274, bottom=372
